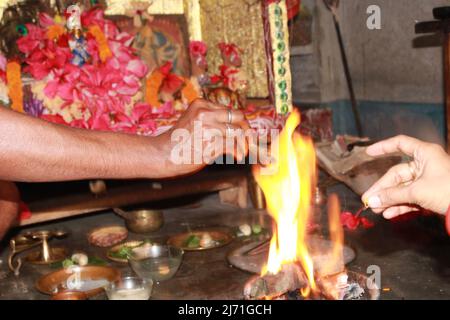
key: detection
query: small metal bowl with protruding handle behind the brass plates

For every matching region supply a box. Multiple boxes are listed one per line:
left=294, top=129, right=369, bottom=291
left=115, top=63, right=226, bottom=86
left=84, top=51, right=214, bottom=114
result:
left=114, top=209, right=164, bottom=233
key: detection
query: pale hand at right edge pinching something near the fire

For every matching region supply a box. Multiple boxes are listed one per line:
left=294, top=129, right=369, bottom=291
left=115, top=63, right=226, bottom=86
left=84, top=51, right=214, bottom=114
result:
left=362, top=136, right=450, bottom=219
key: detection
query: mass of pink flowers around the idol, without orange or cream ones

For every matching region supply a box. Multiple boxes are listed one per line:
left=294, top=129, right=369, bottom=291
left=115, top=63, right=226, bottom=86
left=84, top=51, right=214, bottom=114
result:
left=17, top=9, right=160, bottom=133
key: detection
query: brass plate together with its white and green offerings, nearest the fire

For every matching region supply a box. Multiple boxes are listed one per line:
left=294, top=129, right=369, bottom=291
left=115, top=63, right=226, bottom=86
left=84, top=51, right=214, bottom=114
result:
left=167, top=228, right=233, bottom=251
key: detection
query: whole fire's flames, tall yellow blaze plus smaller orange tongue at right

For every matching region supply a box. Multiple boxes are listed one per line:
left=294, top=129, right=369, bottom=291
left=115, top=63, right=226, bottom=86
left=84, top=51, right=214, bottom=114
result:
left=254, top=111, right=344, bottom=298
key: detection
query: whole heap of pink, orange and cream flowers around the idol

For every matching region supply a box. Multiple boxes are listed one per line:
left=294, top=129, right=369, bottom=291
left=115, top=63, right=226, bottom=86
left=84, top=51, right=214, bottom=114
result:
left=11, top=8, right=184, bottom=134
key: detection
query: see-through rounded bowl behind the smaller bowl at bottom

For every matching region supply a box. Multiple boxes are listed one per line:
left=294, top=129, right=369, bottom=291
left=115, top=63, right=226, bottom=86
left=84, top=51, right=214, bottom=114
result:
left=129, top=245, right=184, bottom=282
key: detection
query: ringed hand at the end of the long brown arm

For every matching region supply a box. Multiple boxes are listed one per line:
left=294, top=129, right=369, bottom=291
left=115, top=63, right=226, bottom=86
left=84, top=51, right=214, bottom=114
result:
left=163, top=99, right=254, bottom=176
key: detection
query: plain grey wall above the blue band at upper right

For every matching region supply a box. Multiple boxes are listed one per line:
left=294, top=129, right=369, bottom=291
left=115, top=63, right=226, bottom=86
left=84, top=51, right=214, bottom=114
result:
left=292, top=0, right=450, bottom=103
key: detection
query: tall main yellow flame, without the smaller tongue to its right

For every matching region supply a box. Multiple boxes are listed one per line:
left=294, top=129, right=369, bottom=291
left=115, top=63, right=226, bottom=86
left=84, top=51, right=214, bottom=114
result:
left=254, top=111, right=316, bottom=295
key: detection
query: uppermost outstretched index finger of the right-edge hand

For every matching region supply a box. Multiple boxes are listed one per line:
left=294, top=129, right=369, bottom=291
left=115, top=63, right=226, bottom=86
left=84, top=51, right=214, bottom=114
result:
left=366, top=136, right=425, bottom=157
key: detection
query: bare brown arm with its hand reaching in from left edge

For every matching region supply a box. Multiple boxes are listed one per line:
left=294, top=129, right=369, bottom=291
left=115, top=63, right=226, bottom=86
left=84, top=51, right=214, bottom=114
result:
left=0, top=100, right=247, bottom=182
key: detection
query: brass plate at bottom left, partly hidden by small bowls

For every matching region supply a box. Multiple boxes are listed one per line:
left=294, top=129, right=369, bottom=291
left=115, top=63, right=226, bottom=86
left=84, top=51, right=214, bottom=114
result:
left=36, top=266, right=121, bottom=298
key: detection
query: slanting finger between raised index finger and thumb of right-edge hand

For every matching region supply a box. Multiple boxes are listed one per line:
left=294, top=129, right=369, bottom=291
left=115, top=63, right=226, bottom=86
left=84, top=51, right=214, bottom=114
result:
left=362, top=163, right=414, bottom=203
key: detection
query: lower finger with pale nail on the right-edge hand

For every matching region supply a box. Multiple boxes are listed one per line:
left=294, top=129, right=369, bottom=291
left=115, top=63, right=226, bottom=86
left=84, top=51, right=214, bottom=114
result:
left=367, top=186, right=415, bottom=213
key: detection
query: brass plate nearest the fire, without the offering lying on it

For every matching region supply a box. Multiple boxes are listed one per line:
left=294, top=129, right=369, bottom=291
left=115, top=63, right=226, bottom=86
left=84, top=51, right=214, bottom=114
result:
left=167, top=228, right=234, bottom=251
